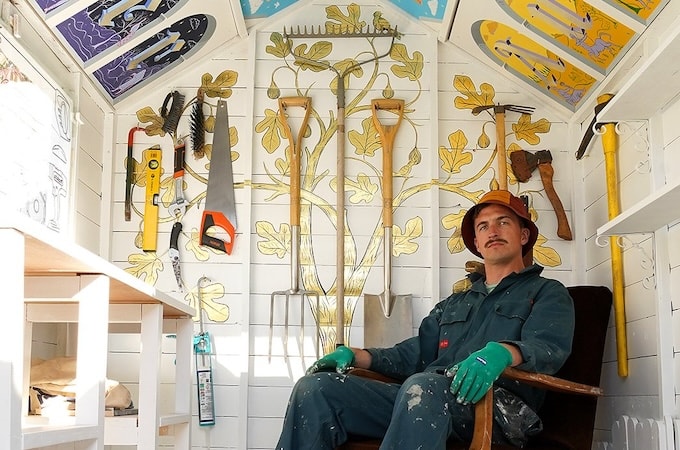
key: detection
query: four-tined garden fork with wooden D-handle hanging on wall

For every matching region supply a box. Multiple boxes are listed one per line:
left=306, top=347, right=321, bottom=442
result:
left=269, top=97, right=320, bottom=361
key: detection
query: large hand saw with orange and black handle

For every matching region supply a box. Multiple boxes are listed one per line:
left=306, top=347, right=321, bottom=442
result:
left=201, top=100, right=236, bottom=255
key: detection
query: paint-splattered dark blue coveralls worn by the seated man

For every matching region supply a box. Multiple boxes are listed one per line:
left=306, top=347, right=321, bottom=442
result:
left=276, top=264, right=574, bottom=450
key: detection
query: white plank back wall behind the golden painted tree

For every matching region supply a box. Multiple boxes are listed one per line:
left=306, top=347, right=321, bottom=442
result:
left=103, top=2, right=574, bottom=450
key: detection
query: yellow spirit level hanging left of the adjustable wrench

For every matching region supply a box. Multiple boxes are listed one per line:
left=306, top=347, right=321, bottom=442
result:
left=142, top=145, right=161, bottom=252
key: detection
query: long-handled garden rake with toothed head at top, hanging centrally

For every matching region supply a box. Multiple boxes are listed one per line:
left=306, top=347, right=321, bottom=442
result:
left=283, top=25, right=399, bottom=346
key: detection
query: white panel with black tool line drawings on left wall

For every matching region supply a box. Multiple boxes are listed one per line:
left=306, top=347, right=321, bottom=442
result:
left=0, top=39, right=72, bottom=231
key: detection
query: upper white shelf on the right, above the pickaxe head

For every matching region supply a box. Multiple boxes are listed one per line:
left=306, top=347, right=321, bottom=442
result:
left=598, top=14, right=680, bottom=122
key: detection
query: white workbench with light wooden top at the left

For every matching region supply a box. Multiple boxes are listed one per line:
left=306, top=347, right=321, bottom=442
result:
left=0, top=214, right=195, bottom=450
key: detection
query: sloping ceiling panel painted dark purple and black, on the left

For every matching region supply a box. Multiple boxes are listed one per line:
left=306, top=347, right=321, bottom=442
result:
left=27, top=0, right=243, bottom=105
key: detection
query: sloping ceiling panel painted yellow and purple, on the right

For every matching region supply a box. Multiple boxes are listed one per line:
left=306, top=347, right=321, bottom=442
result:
left=448, top=0, right=669, bottom=115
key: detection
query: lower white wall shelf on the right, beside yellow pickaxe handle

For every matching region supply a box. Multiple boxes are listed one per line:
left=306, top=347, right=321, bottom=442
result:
left=597, top=179, right=680, bottom=236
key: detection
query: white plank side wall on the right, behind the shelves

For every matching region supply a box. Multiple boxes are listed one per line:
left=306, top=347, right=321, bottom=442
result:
left=583, top=89, right=680, bottom=450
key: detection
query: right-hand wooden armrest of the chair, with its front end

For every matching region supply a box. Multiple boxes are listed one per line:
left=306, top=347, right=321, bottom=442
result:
left=470, top=367, right=603, bottom=450
